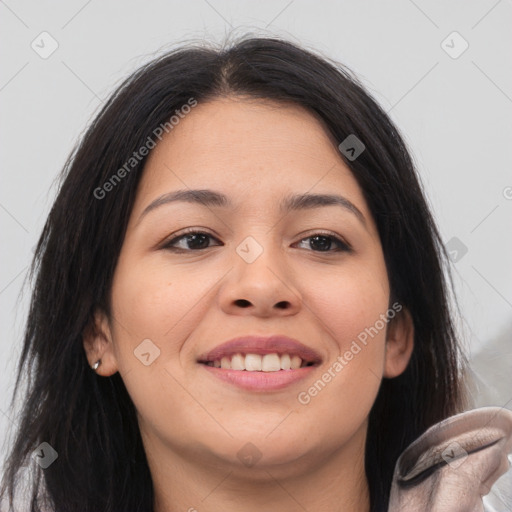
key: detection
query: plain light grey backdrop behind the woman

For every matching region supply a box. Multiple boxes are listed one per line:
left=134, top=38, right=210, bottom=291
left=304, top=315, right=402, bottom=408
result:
left=0, top=0, right=512, bottom=510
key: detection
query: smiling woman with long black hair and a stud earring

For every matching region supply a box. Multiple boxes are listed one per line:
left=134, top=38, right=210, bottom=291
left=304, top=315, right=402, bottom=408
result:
left=4, top=38, right=510, bottom=512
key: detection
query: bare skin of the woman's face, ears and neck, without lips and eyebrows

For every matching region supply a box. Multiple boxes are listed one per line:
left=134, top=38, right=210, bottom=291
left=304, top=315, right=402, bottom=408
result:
left=84, top=97, right=414, bottom=512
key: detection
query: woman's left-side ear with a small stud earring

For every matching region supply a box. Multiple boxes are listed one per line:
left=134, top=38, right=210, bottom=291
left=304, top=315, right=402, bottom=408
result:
left=82, top=310, right=118, bottom=377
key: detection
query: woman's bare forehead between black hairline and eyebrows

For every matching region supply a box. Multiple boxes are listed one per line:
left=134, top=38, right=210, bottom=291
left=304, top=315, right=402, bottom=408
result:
left=135, top=97, right=365, bottom=217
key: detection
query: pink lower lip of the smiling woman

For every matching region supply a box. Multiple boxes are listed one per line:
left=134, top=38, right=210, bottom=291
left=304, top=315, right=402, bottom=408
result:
left=201, top=364, right=316, bottom=391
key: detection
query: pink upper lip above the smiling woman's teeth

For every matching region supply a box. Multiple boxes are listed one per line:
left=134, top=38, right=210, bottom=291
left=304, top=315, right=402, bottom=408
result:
left=198, top=334, right=321, bottom=363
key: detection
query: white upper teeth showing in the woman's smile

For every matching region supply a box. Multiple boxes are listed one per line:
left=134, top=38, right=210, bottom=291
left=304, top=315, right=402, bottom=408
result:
left=208, top=353, right=305, bottom=372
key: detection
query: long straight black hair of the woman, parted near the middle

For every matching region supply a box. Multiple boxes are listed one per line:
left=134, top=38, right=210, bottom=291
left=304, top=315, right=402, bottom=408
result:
left=2, top=37, right=462, bottom=512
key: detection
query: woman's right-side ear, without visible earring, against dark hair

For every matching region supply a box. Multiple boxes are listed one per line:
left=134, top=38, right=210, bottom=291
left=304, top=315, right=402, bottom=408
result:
left=384, top=308, right=414, bottom=379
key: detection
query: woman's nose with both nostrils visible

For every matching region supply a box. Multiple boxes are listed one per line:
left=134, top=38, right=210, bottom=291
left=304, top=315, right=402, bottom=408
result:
left=219, top=241, right=302, bottom=318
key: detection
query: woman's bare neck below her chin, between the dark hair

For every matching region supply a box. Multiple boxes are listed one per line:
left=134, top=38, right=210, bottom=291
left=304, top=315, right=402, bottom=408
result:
left=145, top=424, right=370, bottom=512
